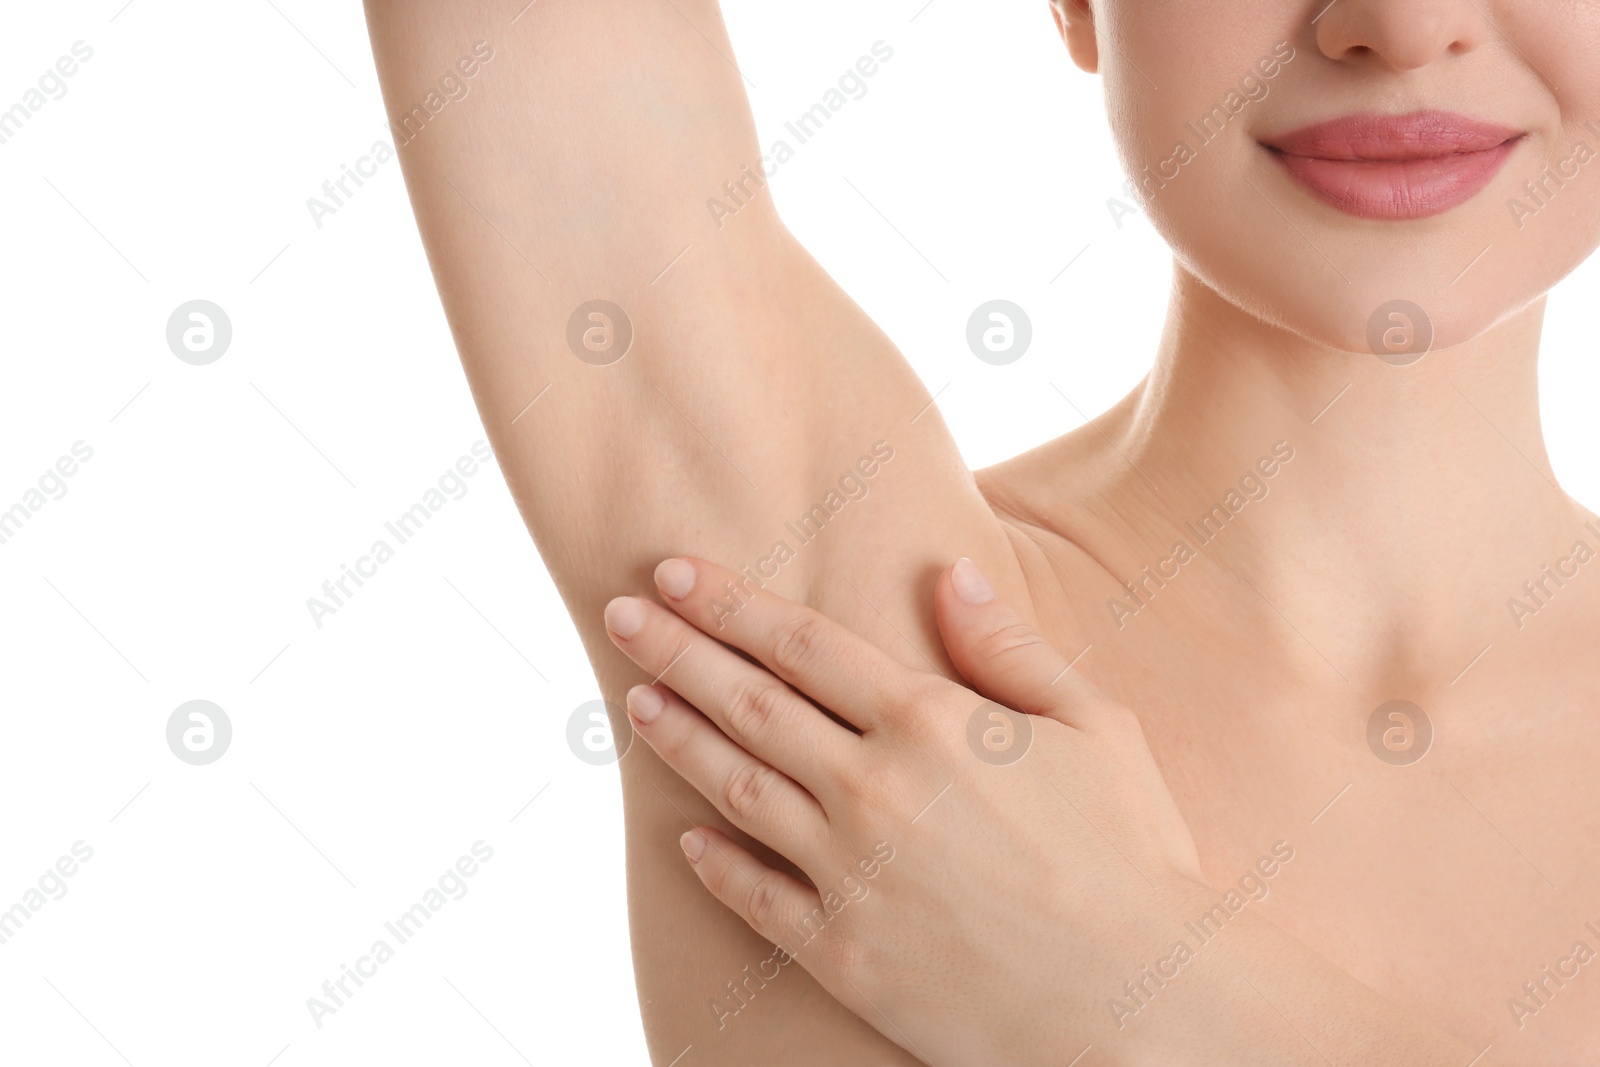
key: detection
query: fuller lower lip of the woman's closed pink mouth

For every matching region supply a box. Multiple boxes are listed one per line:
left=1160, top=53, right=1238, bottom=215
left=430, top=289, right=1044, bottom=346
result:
left=1269, top=138, right=1520, bottom=221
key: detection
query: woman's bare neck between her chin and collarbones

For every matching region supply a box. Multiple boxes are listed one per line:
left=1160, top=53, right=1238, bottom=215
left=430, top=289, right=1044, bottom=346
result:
left=1101, top=267, right=1600, bottom=683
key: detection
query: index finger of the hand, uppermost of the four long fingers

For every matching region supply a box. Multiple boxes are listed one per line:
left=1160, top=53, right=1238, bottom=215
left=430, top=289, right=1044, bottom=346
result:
left=656, top=558, right=918, bottom=731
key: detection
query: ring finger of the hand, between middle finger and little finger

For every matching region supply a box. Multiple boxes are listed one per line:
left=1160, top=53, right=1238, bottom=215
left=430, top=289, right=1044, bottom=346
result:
left=627, top=685, right=827, bottom=865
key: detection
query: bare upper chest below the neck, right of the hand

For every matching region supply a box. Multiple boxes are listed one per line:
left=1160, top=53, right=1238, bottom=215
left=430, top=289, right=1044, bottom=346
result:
left=985, top=489, right=1600, bottom=1067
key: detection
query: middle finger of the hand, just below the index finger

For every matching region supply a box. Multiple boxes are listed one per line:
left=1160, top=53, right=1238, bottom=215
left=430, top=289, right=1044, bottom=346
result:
left=605, top=597, right=861, bottom=797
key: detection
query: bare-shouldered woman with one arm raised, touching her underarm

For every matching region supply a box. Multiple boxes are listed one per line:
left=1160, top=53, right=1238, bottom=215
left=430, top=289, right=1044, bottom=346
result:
left=368, top=0, right=1600, bottom=1064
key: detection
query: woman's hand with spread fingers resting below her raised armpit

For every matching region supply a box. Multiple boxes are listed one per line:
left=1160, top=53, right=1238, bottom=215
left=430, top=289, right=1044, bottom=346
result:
left=606, top=560, right=1208, bottom=1064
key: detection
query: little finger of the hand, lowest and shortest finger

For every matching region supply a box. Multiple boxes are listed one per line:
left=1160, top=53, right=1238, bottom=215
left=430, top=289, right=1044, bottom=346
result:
left=678, top=827, right=822, bottom=974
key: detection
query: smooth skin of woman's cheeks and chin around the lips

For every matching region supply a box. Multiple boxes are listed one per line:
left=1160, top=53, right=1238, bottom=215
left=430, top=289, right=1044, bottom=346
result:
left=1102, top=0, right=1600, bottom=352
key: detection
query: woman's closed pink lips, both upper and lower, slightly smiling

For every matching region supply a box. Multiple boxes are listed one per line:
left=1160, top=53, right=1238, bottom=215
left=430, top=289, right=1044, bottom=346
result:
left=1262, top=110, right=1523, bottom=219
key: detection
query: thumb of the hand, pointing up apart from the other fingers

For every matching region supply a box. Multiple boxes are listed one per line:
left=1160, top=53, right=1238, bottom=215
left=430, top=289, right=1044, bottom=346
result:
left=933, top=557, right=1102, bottom=728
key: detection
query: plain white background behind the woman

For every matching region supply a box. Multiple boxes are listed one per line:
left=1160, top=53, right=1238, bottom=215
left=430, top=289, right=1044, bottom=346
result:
left=0, top=0, right=1600, bottom=1067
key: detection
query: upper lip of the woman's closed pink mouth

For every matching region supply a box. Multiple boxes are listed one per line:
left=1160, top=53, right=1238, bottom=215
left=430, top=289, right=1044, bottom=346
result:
left=1261, top=110, right=1523, bottom=162
